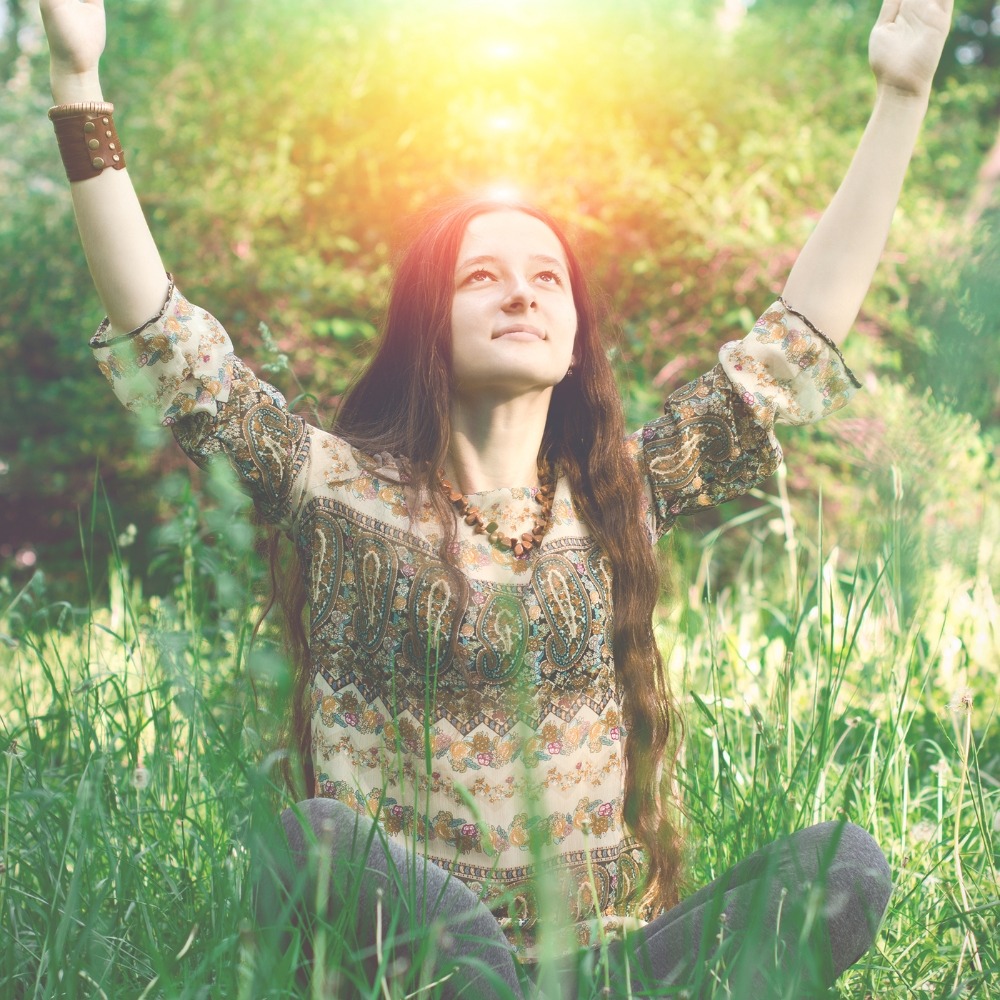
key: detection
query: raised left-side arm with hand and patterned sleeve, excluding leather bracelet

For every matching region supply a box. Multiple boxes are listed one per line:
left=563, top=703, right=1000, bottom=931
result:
left=39, top=0, right=318, bottom=525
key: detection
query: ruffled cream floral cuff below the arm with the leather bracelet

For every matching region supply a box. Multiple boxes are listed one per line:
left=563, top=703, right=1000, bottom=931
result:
left=90, top=278, right=242, bottom=425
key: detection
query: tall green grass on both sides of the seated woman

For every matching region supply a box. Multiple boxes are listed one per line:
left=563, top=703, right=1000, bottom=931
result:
left=0, top=479, right=1000, bottom=1000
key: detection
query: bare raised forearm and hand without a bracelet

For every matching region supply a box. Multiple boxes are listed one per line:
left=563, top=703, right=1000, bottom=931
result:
left=783, top=0, right=953, bottom=343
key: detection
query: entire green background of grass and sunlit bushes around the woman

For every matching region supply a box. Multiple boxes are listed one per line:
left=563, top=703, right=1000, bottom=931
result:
left=0, top=0, right=1000, bottom=1000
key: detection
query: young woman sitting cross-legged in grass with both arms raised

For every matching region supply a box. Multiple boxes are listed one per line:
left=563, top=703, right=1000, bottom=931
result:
left=41, top=0, right=951, bottom=997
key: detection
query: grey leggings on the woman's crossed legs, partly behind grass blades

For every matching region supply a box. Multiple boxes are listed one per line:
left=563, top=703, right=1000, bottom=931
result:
left=259, top=799, right=891, bottom=1000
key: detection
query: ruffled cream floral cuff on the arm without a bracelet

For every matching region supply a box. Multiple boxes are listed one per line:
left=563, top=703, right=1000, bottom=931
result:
left=719, top=299, right=861, bottom=427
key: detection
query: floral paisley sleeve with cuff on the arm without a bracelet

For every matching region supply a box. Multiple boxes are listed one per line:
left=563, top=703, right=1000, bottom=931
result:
left=632, top=301, right=859, bottom=536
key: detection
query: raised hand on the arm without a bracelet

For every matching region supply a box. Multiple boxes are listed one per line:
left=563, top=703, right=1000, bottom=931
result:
left=868, top=0, right=953, bottom=99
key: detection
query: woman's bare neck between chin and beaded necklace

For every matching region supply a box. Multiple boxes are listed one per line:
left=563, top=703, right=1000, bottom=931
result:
left=445, top=388, right=552, bottom=493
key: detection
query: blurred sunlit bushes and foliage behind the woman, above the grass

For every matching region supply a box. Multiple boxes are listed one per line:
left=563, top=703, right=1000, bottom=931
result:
left=0, top=0, right=1000, bottom=600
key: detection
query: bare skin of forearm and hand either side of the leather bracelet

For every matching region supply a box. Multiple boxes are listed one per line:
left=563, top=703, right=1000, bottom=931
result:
left=40, top=0, right=168, bottom=333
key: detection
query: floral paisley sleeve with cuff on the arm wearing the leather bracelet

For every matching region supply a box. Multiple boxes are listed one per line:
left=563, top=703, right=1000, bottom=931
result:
left=90, top=281, right=310, bottom=523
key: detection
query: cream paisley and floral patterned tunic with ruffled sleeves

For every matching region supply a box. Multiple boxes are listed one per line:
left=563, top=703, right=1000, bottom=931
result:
left=91, top=285, right=857, bottom=954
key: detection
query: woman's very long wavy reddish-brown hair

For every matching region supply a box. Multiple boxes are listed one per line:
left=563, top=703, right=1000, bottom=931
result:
left=271, top=199, right=680, bottom=906
